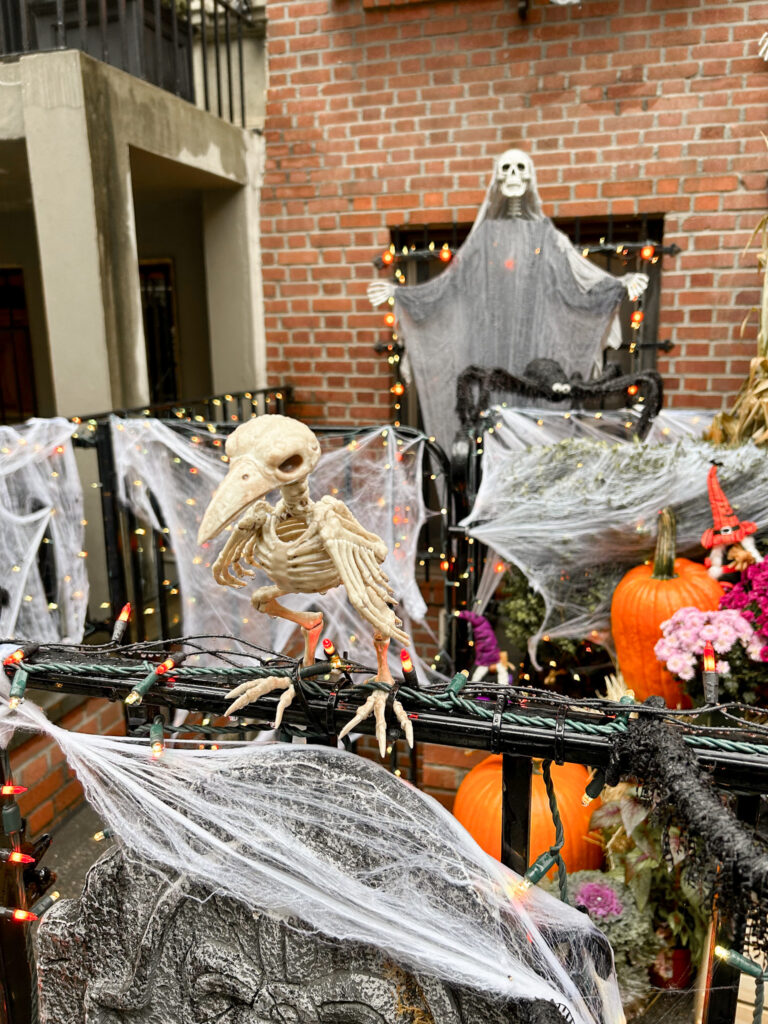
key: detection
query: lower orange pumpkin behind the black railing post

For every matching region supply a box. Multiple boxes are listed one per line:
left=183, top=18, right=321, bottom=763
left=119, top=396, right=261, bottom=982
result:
left=454, top=754, right=603, bottom=873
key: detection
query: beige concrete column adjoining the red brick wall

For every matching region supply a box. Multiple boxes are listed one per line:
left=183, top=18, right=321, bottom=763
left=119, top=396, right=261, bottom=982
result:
left=203, top=130, right=266, bottom=394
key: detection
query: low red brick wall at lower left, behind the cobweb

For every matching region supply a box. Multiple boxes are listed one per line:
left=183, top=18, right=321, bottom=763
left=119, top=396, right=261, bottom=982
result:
left=10, top=699, right=125, bottom=839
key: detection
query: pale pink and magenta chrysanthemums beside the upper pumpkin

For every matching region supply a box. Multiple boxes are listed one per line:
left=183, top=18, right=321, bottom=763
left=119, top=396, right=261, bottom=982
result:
left=654, top=606, right=768, bottom=703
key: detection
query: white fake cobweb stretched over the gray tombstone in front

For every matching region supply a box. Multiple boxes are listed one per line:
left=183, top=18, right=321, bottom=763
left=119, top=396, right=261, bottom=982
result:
left=0, top=671, right=624, bottom=1024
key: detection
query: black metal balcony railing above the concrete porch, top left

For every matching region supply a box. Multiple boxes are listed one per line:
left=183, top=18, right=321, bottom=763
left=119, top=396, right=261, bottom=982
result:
left=0, top=0, right=263, bottom=127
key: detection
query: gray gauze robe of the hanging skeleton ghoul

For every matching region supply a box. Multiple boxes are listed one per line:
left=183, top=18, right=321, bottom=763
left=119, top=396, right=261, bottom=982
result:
left=395, top=217, right=626, bottom=450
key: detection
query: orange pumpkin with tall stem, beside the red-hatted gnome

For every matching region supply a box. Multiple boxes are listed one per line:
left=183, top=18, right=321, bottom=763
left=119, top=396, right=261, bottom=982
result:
left=610, top=509, right=723, bottom=708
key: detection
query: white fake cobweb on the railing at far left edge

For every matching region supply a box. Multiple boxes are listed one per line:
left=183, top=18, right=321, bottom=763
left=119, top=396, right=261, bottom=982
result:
left=0, top=418, right=88, bottom=641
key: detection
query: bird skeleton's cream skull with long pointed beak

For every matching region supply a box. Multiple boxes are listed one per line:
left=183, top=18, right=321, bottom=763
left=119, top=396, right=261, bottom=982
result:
left=198, top=416, right=321, bottom=544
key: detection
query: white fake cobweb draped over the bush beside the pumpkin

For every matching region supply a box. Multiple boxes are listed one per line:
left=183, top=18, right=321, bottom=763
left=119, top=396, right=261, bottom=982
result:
left=463, top=409, right=768, bottom=663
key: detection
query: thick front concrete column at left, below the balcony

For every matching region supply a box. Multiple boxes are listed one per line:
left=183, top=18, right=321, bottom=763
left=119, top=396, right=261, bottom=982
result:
left=19, top=50, right=148, bottom=416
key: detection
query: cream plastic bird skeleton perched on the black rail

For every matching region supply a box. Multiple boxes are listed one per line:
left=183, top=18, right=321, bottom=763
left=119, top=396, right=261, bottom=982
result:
left=198, top=416, right=413, bottom=757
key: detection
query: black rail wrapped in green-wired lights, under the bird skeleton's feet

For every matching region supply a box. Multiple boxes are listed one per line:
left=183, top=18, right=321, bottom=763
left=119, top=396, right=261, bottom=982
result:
left=4, top=637, right=768, bottom=791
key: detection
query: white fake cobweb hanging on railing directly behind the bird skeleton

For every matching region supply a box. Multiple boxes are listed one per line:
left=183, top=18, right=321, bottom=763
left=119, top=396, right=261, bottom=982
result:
left=112, top=417, right=438, bottom=679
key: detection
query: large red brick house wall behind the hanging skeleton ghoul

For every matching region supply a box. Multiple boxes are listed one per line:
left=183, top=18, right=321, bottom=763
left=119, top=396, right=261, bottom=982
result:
left=261, top=0, right=768, bottom=423
